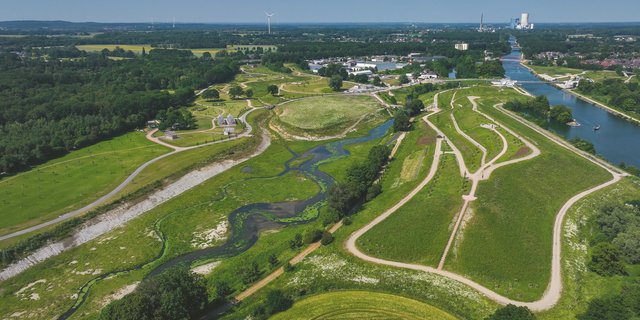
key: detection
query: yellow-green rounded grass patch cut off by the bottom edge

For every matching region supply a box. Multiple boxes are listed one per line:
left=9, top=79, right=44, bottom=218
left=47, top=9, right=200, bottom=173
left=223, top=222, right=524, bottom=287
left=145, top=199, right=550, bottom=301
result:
left=272, top=291, right=456, bottom=320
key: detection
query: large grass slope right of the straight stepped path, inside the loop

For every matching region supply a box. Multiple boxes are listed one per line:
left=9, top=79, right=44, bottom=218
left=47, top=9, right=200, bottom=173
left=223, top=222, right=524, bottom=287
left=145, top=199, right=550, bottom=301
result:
left=445, top=88, right=609, bottom=301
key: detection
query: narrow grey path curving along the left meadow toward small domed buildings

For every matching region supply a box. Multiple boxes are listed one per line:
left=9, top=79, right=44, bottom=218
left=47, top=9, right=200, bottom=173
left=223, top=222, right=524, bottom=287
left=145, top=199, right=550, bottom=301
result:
left=0, top=101, right=257, bottom=241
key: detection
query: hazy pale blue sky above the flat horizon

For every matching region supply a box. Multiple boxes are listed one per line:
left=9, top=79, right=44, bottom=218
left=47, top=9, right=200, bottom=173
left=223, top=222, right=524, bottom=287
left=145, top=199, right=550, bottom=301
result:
left=0, top=0, right=640, bottom=24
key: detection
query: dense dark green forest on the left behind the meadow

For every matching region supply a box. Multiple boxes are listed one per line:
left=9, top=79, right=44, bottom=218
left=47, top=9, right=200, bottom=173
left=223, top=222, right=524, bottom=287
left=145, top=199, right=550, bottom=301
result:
left=0, top=48, right=239, bottom=173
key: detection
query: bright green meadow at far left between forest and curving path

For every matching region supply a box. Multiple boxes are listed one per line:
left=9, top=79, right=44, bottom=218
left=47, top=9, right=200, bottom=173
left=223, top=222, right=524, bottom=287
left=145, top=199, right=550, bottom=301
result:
left=0, top=132, right=169, bottom=234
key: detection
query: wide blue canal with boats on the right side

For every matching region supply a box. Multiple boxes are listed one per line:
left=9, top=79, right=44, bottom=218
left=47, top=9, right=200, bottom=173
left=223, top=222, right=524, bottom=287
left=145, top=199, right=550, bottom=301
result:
left=503, top=38, right=640, bottom=168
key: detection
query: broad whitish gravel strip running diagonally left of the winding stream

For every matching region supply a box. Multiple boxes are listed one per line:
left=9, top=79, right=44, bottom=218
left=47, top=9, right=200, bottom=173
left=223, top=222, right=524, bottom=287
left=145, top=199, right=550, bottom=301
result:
left=0, top=109, right=271, bottom=281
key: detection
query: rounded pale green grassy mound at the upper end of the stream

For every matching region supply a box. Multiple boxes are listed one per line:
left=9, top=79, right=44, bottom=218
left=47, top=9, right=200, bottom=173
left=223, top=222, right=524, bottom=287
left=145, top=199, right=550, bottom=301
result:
left=276, top=96, right=381, bottom=134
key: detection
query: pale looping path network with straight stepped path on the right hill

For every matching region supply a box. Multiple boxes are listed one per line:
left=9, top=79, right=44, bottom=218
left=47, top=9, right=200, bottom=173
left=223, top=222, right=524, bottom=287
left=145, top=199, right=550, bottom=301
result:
left=345, top=90, right=626, bottom=311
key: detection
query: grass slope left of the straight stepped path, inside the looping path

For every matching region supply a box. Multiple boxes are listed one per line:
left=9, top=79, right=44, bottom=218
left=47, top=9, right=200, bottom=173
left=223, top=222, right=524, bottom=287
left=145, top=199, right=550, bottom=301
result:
left=358, top=150, right=466, bottom=267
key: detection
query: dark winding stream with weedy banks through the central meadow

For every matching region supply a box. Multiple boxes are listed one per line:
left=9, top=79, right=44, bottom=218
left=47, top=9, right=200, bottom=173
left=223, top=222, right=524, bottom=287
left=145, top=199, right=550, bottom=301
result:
left=58, top=120, right=393, bottom=319
